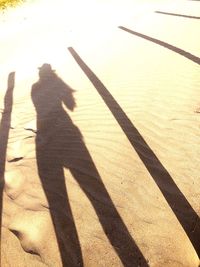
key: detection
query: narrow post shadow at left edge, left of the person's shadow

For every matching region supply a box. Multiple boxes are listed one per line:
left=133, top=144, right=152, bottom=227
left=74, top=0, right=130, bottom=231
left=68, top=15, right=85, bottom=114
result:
left=0, top=72, right=15, bottom=258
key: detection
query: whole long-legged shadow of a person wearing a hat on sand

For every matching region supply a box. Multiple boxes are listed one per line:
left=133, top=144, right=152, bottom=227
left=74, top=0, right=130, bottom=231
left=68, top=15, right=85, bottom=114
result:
left=31, top=63, right=148, bottom=267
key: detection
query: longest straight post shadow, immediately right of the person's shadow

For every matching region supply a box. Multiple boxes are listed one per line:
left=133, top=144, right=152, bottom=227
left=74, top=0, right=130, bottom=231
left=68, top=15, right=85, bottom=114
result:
left=68, top=47, right=200, bottom=255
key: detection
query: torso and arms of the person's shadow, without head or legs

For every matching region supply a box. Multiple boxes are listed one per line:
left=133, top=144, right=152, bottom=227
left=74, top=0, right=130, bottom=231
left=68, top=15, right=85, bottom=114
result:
left=32, top=73, right=83, bottom=171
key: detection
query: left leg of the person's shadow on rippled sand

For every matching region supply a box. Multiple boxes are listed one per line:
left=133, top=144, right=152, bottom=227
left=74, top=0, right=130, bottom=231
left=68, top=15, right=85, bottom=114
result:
left=37, top=148, right=83, bottom=267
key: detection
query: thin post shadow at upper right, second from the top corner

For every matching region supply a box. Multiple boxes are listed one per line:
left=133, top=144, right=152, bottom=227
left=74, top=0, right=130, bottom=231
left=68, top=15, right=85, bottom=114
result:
left=119, top=26, right=200, bottom=64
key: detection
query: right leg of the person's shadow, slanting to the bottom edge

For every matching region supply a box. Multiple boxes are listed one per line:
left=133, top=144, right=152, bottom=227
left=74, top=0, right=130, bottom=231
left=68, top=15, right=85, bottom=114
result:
left=70, top=146, right=148, bottom=267
